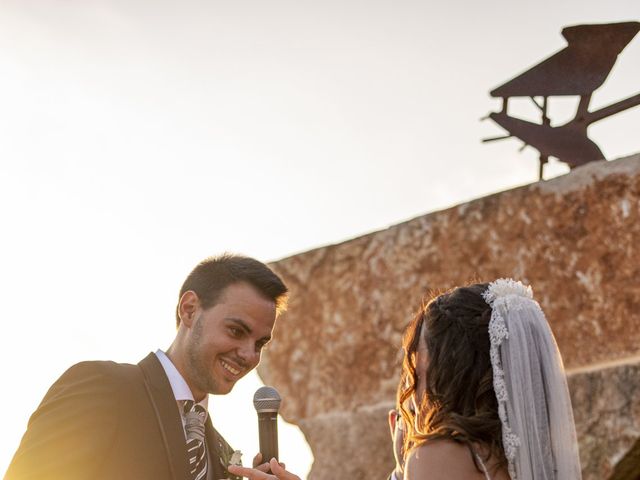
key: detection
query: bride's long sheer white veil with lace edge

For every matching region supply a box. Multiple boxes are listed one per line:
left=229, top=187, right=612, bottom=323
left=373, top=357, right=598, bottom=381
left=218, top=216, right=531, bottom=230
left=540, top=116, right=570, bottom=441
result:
left=484, top=279, right=581, bottom=480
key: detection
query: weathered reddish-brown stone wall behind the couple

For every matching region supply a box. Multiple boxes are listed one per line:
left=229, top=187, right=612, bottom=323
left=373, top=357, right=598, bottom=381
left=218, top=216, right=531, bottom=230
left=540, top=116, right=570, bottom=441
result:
left=259, top=155, right=640, bottom=480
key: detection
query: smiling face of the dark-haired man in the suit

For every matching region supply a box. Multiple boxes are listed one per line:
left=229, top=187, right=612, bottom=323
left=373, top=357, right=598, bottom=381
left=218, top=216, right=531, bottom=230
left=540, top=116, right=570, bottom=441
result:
left=184, top=283, right=276, bottom=400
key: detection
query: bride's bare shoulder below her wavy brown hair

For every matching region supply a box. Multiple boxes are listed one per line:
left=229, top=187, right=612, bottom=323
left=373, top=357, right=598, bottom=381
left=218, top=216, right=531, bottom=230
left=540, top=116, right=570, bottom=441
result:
left=405, top=440, right=485, bottom=480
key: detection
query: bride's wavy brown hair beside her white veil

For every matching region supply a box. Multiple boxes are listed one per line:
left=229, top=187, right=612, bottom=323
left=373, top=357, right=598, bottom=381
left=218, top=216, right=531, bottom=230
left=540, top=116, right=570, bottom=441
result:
left=397, top=283, right=506, bottom=467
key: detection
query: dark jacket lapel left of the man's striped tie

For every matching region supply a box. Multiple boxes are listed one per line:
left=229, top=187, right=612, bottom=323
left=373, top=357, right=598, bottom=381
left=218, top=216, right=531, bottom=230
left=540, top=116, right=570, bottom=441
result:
left=138, top=353, right=191, bottom=480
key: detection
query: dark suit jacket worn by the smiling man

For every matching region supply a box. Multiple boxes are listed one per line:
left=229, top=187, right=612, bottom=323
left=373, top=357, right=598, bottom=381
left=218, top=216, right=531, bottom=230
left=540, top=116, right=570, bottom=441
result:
left=5, top=353, right=232, bottom=480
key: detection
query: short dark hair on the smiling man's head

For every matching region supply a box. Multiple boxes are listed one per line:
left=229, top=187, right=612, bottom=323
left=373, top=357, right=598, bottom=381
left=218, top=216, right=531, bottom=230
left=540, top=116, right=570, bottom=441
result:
left=176, top=253, right=288, bottom=325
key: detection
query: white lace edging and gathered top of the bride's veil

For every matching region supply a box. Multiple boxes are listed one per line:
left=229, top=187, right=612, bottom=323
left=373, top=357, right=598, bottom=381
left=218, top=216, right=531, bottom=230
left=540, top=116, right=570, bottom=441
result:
left=482, top=278, right=535, bottom=480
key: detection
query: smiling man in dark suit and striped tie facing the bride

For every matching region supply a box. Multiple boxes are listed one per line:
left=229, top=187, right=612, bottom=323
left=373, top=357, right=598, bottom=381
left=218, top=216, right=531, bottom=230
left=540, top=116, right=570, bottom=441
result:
left=5, top=255, right=287, bottom=480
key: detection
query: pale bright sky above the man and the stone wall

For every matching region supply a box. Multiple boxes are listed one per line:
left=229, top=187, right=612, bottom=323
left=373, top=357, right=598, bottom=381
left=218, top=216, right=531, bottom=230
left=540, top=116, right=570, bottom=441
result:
left=0, top=0, right=640, bottom=475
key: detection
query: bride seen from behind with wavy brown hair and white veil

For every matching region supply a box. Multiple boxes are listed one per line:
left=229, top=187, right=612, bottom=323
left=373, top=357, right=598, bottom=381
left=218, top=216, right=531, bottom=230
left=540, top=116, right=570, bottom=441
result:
left=229, top=279, right=581, bottom=480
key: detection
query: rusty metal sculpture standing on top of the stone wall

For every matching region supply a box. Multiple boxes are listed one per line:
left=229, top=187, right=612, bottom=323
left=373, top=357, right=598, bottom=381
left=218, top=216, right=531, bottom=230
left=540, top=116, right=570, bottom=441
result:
left=483, top=22, right=640, bottom=180
